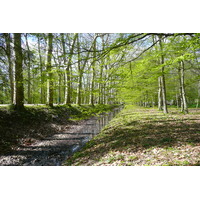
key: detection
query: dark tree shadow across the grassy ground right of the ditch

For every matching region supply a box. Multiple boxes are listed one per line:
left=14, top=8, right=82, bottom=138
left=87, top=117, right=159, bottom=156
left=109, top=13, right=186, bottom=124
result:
left=66, top=108, right=200, bottom=166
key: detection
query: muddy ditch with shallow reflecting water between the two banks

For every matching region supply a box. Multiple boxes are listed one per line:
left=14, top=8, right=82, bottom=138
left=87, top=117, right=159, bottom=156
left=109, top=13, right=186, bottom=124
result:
left=0, top=108, right=122, bottom=166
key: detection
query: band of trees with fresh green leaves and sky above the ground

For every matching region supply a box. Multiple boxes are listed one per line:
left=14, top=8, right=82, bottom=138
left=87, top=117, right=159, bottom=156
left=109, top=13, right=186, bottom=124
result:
left=0, top=33, right=200, bottom=113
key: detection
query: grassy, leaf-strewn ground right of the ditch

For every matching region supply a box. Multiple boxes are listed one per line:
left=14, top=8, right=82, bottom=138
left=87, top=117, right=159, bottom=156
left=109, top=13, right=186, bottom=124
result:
left=64, top=106, right=200, bottom=166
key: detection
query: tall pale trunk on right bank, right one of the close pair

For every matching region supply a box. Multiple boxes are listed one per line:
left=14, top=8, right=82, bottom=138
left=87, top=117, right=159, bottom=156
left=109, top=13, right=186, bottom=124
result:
left=159, top=37, right=168, bottom=113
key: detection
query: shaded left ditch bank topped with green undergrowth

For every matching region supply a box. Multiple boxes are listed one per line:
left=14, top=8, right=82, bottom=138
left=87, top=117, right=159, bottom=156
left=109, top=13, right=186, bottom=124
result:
left=0, top=105, right=118, bottom=154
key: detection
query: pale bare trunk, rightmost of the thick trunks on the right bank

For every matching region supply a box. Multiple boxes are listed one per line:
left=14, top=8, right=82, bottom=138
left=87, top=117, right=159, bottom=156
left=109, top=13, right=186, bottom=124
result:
left=180, top=61, right=188, bottom=113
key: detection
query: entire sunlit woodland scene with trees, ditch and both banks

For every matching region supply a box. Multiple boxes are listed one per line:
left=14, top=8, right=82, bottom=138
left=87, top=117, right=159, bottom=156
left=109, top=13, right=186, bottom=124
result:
left=0, top=33, right=200, bottom=166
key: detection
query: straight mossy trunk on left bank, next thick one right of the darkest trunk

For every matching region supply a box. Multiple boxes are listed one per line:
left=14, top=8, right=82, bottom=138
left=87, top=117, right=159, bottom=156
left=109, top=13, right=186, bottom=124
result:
left=47, top=33, right=53, bottom=107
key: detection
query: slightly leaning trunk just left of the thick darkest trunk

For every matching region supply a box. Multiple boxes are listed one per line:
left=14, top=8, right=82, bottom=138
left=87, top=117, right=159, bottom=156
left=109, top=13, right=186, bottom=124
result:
left=4, top=33, right=14, bottom=104
